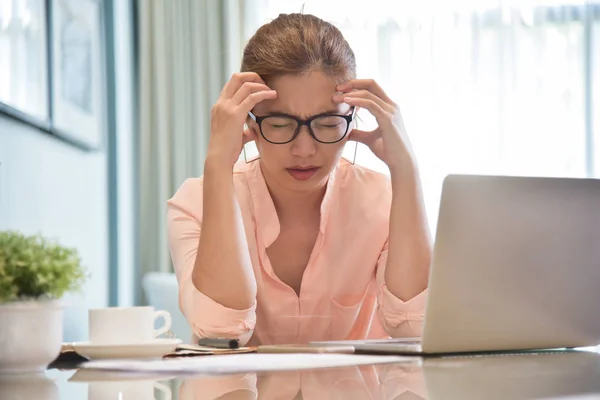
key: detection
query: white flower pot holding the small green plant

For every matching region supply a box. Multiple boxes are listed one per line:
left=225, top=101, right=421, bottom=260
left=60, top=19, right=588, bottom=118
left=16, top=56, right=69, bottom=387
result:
left=0, top=301, right=64, bottom=374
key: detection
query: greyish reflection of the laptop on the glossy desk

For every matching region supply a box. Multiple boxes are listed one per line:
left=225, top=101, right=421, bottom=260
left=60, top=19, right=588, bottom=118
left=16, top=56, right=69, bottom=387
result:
left=422, top=350, right=600, bottom=400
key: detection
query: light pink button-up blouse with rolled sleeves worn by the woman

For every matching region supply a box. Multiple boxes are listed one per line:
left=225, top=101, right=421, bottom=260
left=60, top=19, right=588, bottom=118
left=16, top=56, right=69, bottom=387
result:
left=168, top=159, right=426, bottom=346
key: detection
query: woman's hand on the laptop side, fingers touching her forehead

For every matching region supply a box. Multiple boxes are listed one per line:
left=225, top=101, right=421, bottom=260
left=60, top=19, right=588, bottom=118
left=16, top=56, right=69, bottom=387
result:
left=333, top=79, right=415, bottom=173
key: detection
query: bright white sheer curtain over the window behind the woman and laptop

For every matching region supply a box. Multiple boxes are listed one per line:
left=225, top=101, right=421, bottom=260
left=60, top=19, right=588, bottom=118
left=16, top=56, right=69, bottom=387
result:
left=255, top=0, right=600, bottom=230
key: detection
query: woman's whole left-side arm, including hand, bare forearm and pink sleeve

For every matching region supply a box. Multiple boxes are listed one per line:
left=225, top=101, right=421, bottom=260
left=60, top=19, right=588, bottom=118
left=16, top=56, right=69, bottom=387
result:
left=168, top=72, right=277, bottom=343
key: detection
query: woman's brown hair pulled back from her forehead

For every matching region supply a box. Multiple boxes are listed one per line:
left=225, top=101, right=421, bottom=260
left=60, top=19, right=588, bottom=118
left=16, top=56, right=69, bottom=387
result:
left=241, top=14, right=356, bottom=82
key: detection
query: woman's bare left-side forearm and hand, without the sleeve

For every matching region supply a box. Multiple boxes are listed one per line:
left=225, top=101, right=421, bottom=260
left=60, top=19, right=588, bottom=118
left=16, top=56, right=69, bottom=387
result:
left=192, top=72, right=276, bottom=310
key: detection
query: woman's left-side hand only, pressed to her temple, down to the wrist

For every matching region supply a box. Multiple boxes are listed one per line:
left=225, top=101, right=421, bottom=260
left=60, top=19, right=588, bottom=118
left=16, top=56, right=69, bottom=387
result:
left=206, top=72, right=277, bottom=168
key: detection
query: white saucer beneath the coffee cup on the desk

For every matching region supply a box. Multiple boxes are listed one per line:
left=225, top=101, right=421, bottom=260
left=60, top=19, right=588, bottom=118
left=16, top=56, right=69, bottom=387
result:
left=70, top=339, right=181, bottom=360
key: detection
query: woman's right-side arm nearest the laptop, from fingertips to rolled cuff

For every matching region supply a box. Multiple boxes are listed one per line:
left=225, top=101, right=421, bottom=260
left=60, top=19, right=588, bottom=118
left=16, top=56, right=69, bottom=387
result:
left=333, top=79, right=432, bottom=337
